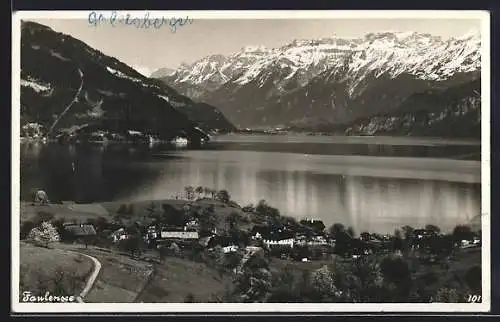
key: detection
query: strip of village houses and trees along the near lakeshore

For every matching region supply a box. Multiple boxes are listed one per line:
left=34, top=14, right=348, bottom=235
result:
left=21, top=187, right=481, bottom=262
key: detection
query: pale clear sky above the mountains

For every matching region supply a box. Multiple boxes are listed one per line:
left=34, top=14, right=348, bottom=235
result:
left=29, top=18, right=480, bottom=76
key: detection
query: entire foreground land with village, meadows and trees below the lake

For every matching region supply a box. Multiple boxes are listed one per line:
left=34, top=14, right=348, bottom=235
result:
left=20, top=186, right=481, bottom=302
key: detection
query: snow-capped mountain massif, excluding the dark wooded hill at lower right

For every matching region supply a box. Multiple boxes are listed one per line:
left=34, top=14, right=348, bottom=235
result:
left=156, top=32, right=481, bottom=131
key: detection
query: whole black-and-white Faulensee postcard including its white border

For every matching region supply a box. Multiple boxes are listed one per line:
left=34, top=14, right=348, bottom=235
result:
left=11, top=10, right=491, bottom=313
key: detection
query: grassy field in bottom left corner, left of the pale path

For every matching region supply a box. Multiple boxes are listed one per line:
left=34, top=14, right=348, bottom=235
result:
left=19, top=243, right=93, bottom=296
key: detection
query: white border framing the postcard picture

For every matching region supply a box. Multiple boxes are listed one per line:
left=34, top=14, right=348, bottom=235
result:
left=11, top=10, right=491, bottom=313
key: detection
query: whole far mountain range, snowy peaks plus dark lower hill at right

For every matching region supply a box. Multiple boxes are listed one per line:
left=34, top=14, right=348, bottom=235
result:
left=152, top=32, right=481, bottom=137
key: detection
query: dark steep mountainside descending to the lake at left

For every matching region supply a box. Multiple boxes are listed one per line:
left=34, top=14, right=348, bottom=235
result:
left=21, top=22, right=232, bottom=139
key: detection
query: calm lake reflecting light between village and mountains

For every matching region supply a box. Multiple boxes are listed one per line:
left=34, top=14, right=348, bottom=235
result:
left=20, top=135, right=481, bottom=232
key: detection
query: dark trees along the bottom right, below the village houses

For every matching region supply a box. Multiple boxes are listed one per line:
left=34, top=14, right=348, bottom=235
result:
left=209, top=248, right=481, bottom=303
